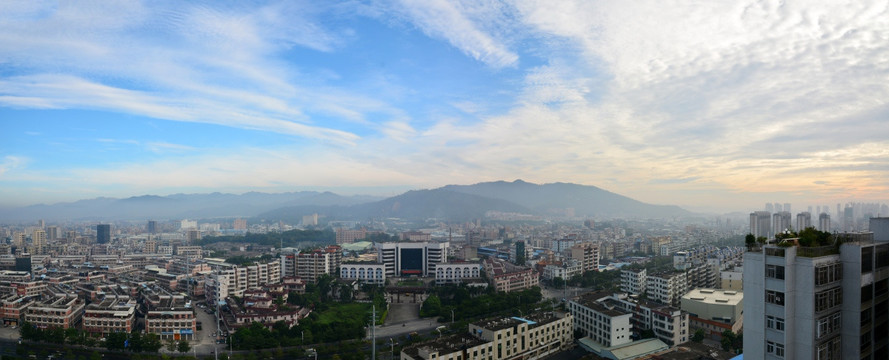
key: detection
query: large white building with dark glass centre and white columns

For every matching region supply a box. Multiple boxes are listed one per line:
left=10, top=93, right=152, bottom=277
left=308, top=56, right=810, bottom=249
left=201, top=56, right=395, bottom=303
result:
left=377, top=241, right=448, bottom=277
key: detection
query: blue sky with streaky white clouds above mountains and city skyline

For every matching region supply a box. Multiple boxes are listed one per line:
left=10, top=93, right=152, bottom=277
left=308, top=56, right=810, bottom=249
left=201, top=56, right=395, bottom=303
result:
left=0, top=0, right=889, bottom=211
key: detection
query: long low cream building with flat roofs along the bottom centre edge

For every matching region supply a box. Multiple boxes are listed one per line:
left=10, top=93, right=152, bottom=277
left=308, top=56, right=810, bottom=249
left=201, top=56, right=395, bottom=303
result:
left=401, top=312, right=573, bottom=360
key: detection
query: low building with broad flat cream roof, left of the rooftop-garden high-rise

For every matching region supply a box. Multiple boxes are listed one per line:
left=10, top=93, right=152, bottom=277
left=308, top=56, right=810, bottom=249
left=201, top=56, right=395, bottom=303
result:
left=681, top=289, right=744, bottom=340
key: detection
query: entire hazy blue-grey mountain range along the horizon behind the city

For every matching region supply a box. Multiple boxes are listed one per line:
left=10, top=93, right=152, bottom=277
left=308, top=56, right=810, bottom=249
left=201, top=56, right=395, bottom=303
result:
left=0, top=180, right=691, bottom=223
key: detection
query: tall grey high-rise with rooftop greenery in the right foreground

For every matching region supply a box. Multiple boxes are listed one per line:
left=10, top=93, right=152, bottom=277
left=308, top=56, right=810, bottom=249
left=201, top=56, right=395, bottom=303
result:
left=744, top=218, right=889, bottom=359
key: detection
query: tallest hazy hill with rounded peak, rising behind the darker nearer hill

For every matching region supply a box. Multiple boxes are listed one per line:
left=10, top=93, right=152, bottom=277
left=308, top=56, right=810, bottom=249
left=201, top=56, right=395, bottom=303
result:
left=441, top=180, right=691, bottom=218
